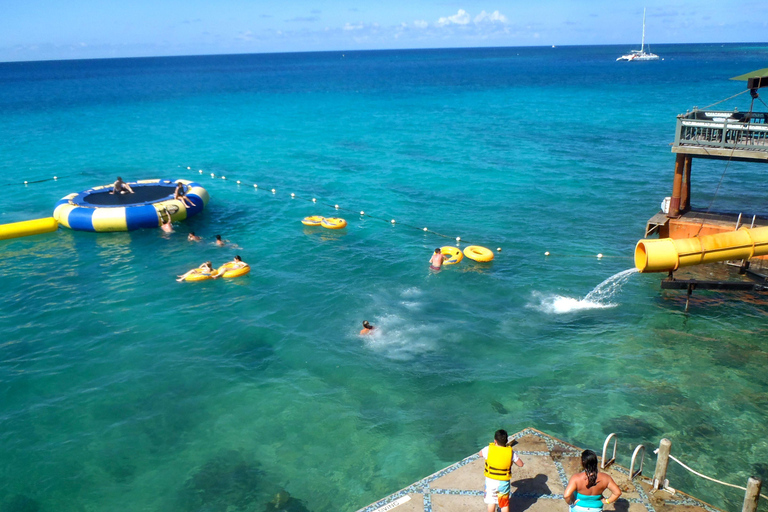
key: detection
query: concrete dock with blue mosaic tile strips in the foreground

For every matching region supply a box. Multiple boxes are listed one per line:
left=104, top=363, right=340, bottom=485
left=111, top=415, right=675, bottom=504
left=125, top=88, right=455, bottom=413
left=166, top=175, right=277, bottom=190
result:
left=358, top=428, right=723, bottom=512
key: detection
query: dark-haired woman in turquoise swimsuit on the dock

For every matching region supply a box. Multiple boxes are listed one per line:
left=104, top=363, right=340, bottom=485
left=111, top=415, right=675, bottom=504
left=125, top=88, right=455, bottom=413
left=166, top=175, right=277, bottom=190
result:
left=563, top=450, right=621, bottom=512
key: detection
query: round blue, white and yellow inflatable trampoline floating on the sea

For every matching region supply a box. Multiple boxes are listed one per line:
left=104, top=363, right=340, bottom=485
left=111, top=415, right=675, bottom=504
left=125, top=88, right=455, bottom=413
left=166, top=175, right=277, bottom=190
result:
left=53, top=180, right=209, bottom=232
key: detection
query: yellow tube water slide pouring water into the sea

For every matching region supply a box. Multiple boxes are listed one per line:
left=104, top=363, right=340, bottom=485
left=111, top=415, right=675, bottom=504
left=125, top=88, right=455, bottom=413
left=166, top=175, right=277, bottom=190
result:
left=635, top=226, right=768, bottom=272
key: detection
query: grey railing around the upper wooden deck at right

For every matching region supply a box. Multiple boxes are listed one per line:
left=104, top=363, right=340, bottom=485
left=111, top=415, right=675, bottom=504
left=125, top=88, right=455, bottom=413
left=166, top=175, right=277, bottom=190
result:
left=673, top=109, right=768, bottom=153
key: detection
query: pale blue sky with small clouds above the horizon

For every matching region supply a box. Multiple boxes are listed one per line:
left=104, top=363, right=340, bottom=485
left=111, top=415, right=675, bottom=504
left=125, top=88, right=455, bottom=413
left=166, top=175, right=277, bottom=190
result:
left=0, top=0, right=768, bottom=62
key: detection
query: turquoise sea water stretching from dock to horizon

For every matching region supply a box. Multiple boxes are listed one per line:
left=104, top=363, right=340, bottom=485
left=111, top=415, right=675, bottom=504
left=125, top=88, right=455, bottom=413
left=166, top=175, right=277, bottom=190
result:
left=0, top=44, right=768, bottom=512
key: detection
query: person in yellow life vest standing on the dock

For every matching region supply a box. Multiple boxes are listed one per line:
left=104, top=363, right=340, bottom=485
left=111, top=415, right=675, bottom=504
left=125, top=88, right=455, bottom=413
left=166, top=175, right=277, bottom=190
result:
left=480, top=430, right=523, bottom=512
